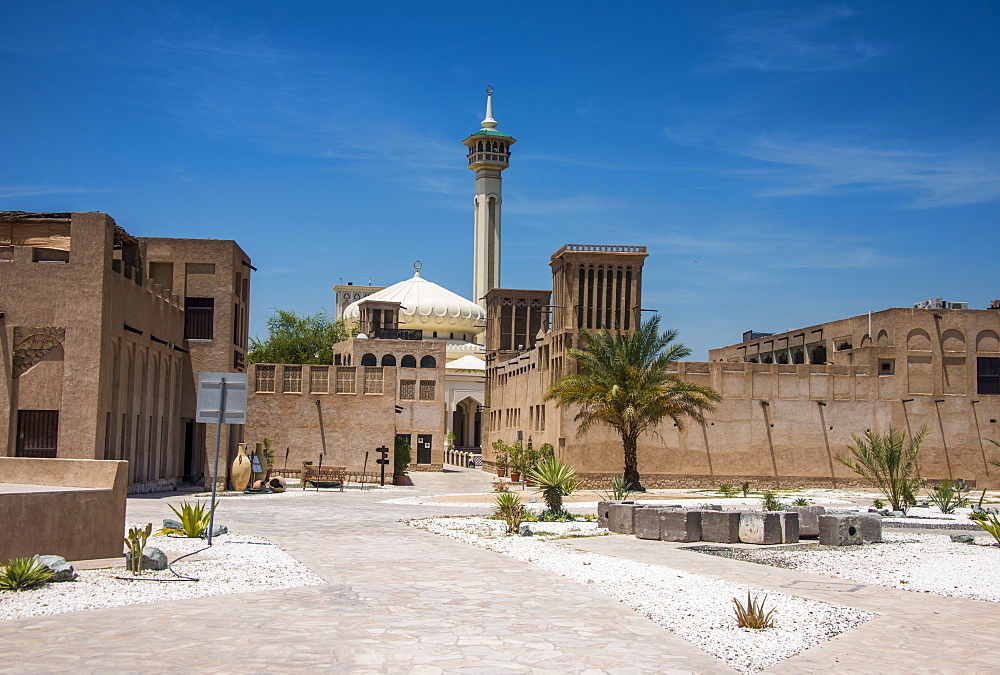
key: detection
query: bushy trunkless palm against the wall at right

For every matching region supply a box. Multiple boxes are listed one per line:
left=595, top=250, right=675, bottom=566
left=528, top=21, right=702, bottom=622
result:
left=837, top=426, right=928, bottom=511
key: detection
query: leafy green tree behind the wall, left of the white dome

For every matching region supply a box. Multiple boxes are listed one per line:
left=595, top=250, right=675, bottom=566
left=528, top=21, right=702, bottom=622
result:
left=247, top=309, right=356, bottom=364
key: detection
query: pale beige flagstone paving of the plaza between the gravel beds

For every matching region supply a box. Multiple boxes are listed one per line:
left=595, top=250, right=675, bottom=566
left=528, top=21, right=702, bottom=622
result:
left=0, top=470, right=1000, bottom=673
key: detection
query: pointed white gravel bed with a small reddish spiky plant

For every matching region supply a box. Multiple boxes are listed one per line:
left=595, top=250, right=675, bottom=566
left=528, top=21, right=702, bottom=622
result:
left=408, top=518, right=877, bottom=673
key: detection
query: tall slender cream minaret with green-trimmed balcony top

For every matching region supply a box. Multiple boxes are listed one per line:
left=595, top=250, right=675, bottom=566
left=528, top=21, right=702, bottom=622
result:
left=462, top=87, right=516, bottom=306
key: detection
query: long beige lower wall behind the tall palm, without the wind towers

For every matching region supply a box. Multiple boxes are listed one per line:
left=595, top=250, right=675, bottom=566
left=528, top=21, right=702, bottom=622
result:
left=484, top=354, right=1000, bottom=486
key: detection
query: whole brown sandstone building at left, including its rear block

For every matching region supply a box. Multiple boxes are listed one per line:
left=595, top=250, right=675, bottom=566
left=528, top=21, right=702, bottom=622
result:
left=0, top=212, right=250, bottom=492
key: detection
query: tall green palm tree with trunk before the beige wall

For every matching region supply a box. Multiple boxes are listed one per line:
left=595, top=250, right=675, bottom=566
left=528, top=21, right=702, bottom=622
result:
left=545, top=316, right=722, bottom=491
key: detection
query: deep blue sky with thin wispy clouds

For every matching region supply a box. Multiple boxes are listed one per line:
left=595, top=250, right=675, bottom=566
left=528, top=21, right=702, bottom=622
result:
left=0, top=0, right=1000, bottom=359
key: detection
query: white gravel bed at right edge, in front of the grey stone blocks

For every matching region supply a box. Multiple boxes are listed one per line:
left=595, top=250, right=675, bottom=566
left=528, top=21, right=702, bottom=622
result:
left=693, top=533, right=1000, bottom=602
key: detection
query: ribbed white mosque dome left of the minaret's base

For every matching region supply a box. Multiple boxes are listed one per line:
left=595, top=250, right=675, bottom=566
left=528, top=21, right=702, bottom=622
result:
left=344, top=272, right=486, bottom=340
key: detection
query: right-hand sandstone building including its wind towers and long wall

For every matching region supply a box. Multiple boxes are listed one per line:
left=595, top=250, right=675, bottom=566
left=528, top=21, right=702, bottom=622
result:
left=484, top=246, right=1000, bottom=487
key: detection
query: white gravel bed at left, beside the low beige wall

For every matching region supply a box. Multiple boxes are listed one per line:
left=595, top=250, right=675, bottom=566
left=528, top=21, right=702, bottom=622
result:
left=0, top=533, right=326, bottom=621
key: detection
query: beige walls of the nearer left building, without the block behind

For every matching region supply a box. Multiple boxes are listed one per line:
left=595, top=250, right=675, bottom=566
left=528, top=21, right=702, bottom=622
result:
left=0, top=213, right=184, bottom=494
